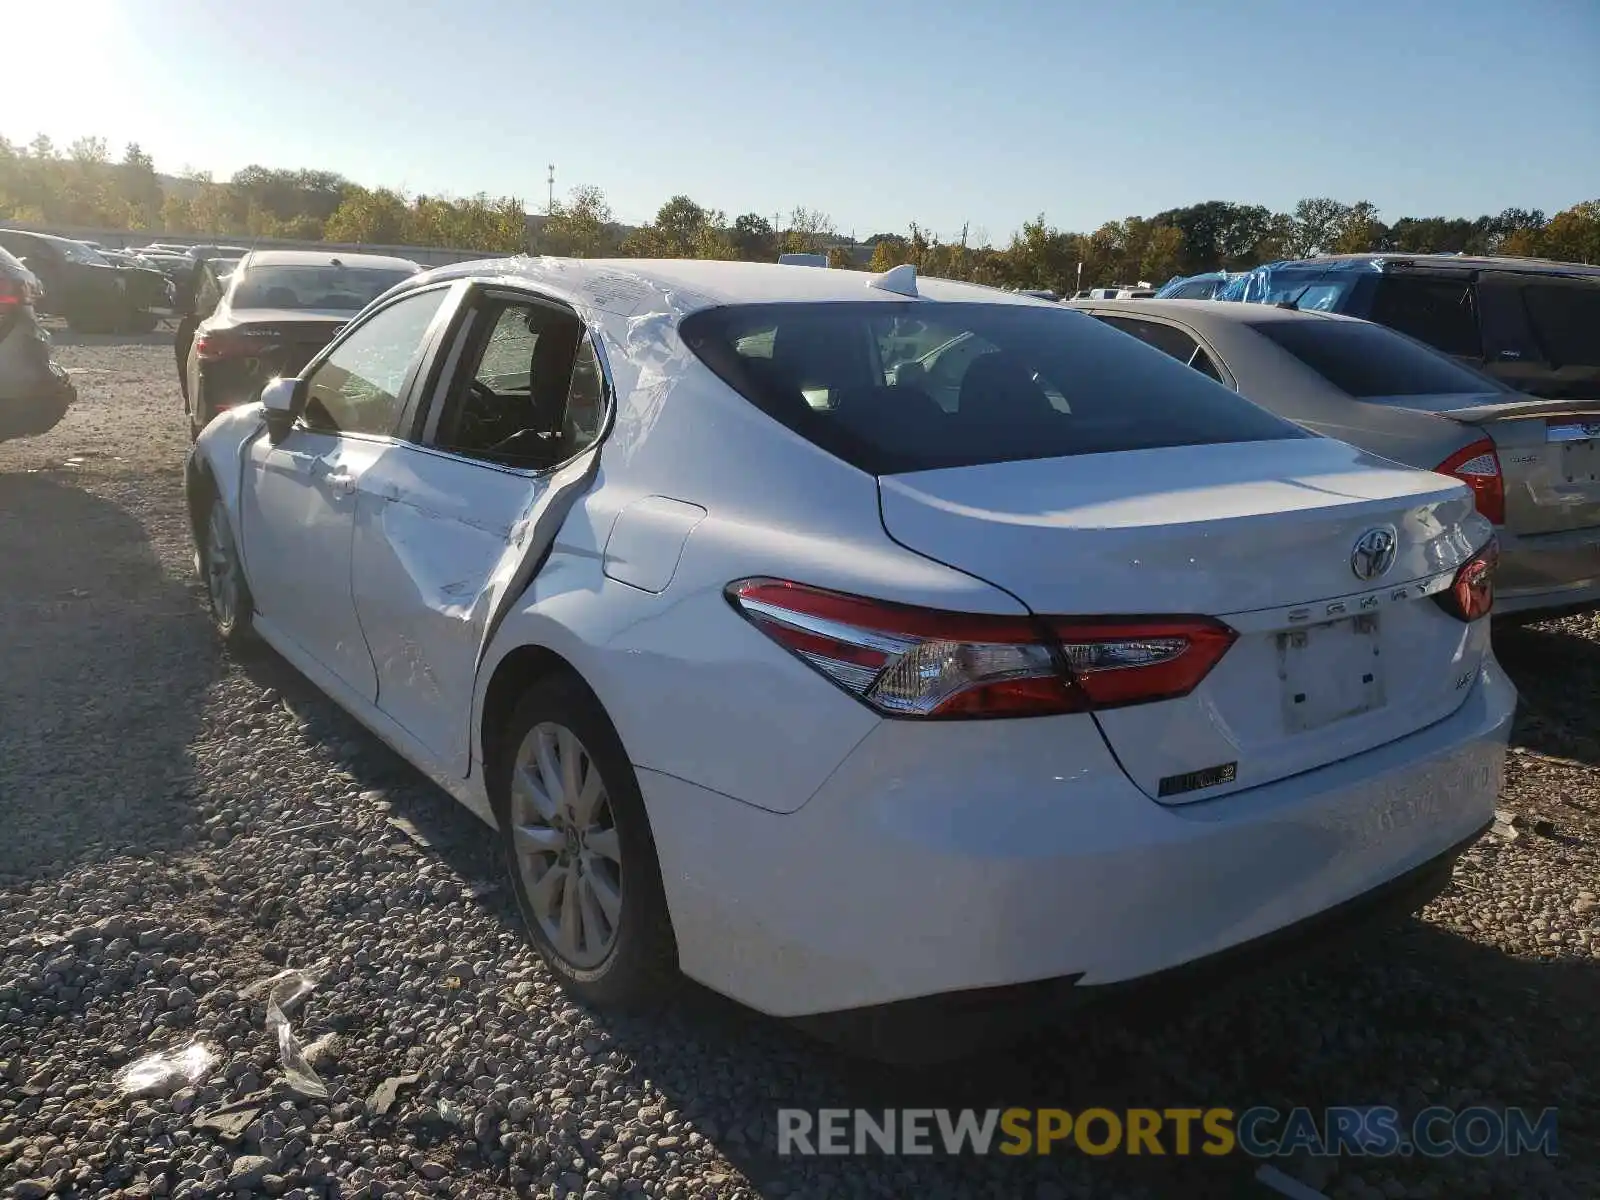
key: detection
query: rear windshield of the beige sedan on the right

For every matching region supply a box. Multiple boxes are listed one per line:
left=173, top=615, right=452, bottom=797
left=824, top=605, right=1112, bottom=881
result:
left=1251, top=317, right=1506, bottom=400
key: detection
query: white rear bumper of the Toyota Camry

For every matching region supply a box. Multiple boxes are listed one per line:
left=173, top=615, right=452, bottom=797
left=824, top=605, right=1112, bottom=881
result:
left=638, top=658, right=1517, bottom=1036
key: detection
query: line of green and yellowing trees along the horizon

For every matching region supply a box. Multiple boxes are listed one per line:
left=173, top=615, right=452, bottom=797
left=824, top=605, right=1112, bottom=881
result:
left=0, top=136, right=1600, bottom=293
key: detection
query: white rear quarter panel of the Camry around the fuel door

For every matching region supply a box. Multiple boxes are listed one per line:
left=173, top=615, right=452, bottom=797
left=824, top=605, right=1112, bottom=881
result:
left=474, top=358, right=1022, bottom=813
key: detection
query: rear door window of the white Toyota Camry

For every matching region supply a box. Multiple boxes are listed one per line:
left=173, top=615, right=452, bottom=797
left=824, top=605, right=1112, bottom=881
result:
left=424, top=299, right=605, bottom=470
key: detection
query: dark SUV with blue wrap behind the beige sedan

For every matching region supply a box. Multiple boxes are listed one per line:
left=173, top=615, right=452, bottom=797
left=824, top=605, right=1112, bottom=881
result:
left=1218, top=254, right=1600, bottom=402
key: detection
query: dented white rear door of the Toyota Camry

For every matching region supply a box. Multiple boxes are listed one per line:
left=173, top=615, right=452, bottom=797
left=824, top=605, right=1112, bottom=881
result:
left=352, top=445, right=600, bottom=778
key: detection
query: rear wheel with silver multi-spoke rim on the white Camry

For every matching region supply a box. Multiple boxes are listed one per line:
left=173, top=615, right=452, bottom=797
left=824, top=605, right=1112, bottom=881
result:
left=490, top=675, right=678, bottom=1008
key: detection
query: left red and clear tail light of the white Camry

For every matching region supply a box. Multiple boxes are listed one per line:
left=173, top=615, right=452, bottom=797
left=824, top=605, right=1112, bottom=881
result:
left=728, top=579, right=1238, bottom=718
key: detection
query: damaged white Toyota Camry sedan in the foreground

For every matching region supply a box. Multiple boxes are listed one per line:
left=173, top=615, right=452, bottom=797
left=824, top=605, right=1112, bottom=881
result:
left=187, top=258, right=1515, bottom=1058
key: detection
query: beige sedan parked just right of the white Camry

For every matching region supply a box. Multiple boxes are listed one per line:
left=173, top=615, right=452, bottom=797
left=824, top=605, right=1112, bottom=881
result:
left=1078, top=293, right=1600, bottom=616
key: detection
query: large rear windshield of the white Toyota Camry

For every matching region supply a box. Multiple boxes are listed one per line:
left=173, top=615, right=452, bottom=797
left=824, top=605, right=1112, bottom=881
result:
left=682, top=301, right=1309, bottom=475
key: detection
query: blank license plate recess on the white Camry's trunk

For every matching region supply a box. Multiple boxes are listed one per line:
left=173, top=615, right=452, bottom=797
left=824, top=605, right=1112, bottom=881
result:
left=1277, top=613, right=1384, bottom=733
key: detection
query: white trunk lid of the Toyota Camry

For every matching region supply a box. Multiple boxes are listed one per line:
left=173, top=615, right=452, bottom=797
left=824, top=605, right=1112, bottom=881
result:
left=880, top=438, right=1491, bottom=803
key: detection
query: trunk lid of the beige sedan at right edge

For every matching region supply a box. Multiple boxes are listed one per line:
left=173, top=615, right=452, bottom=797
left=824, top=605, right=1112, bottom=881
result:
left=1392, top=394, right=1600, bottom=536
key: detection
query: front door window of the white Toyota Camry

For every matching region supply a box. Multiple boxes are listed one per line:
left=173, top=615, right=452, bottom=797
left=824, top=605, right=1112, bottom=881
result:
left=304, top=288, right=445, bottom=434
